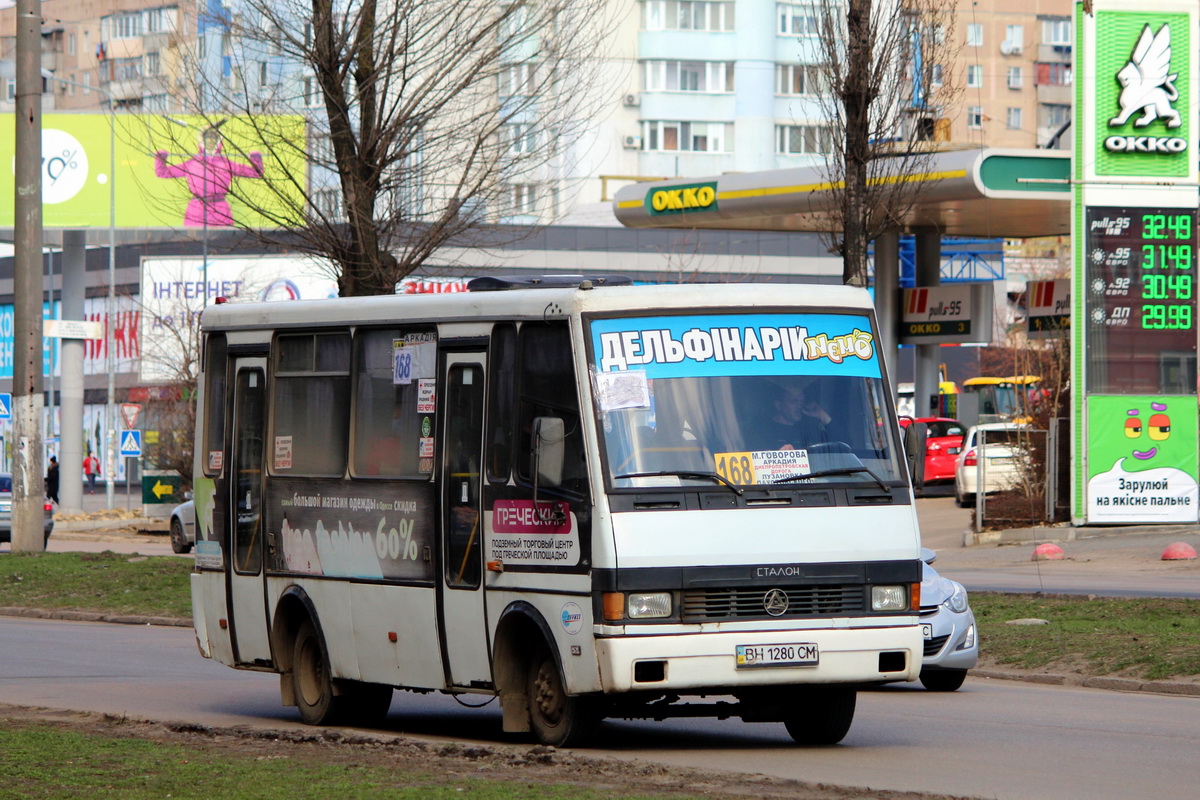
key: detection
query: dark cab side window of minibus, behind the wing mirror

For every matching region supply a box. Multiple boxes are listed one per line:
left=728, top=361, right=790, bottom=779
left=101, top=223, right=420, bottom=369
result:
left=516, top=323, right=588, bottom=497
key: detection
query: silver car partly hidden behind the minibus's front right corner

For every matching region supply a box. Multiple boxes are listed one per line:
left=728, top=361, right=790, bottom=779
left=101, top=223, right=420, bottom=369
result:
left=920, top=547, right=979, bottom=692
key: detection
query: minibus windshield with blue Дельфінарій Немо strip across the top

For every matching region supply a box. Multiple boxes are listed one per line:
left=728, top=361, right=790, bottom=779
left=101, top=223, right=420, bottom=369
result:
left=590, top=313, right=905, bottom=491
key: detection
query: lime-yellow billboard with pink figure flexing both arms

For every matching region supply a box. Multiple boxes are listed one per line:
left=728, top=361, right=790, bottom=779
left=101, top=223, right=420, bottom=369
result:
left=0, top=114, right=307, bottom=229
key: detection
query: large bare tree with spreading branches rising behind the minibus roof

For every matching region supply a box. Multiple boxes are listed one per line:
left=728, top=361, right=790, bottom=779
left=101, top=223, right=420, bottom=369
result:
left=166, top=0, right=616, bottom=296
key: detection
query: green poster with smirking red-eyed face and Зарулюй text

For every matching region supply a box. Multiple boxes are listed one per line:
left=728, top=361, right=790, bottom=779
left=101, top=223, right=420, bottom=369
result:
left=1087, top=395, right=1198, bottom=523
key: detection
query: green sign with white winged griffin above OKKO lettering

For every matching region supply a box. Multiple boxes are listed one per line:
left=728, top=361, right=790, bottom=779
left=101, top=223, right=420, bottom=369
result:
left=1096, top=12, right=1189, bottom=176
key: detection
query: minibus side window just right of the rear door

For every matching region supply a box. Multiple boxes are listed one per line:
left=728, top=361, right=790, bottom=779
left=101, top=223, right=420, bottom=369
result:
left=266, top=332, right=350, bottom=476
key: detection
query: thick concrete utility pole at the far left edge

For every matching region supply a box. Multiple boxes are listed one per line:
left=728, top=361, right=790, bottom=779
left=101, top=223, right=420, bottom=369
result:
left=12, top=0, right=44, bottom=552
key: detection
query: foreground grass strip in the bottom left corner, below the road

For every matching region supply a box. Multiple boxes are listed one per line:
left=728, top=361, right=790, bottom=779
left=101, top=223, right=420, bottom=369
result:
left=0, top=720, right=672, bottom=800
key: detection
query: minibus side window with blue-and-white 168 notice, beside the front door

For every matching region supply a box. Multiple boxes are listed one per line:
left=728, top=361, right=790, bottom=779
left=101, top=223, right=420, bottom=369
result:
left=350, top=327, right=437, bottom=479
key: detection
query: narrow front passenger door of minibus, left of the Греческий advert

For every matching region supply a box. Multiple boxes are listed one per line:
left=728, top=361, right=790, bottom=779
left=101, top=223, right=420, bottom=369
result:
left=439, top=351, right=492, bottom=686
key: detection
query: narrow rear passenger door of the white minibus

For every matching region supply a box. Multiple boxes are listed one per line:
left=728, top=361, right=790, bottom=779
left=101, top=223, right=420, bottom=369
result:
left=221, top=357, right=271, bottom=664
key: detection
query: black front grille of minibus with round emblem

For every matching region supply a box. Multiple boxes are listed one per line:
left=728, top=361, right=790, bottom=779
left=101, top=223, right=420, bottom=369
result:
left=682, top=584, right=865, bottom=622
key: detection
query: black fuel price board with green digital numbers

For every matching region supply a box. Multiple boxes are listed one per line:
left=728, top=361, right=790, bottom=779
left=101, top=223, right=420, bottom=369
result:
left=1085, top=206, right=1196, bottom=393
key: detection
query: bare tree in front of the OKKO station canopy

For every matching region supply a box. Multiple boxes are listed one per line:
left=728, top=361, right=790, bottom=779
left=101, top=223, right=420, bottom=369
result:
left=806, top=0, right=959, bottom=285
